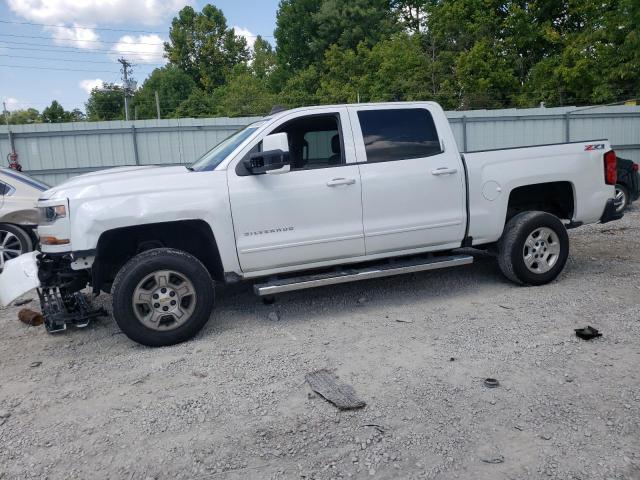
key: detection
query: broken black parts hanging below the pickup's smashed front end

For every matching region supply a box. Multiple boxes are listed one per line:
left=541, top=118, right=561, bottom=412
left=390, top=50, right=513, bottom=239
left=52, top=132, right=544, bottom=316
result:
left=37, top=253, right=107, bottom=333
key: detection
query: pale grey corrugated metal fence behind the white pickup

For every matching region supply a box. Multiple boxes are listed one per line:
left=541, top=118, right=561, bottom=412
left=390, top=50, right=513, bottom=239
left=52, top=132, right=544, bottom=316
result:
left=0, top=106, right=640, bottom=185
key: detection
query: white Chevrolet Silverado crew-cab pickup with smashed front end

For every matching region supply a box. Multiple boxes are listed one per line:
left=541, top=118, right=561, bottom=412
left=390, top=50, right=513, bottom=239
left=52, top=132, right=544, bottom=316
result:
left=0, top=102, right=622, bottom=346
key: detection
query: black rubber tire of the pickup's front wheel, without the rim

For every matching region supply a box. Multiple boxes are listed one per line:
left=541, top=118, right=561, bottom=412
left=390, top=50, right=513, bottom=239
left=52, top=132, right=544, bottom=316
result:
left=112, top=248, right=214, bottom=347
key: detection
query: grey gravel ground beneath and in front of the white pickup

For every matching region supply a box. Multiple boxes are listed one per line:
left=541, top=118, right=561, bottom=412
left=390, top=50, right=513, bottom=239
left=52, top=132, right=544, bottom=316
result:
left=0, top=207, right=640, bottom=480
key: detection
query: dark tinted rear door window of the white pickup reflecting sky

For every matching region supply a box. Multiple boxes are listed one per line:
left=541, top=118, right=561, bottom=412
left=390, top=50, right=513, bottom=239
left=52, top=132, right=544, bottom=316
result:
left=358, top=108, right=442, bottom=163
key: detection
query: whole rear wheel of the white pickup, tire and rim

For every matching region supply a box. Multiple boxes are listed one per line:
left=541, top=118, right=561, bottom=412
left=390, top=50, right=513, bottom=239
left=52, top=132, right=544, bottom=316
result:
left=498, top=212, right=569, bottom=285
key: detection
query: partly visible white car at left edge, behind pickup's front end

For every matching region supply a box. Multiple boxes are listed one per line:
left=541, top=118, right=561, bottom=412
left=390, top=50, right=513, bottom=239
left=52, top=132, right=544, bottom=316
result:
left=0, top=168, right=50, bottom=271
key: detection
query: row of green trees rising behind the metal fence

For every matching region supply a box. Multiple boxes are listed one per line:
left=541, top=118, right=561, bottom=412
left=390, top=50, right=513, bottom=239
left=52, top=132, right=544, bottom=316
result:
left=2, top=0, right=640, bottom=124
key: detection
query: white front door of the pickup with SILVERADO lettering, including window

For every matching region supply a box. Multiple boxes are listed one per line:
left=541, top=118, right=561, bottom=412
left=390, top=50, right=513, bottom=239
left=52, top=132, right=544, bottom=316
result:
left=227, top=108, right=364, bottom=273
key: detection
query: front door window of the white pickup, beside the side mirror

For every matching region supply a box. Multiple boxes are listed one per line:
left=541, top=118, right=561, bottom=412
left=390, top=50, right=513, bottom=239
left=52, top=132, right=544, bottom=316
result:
left=273, top=114, right=345, bottom=170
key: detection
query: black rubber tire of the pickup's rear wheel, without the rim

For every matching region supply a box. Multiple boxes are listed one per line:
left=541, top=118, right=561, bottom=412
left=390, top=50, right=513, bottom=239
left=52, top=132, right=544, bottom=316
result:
left=498, top=212, right=569, bottom=285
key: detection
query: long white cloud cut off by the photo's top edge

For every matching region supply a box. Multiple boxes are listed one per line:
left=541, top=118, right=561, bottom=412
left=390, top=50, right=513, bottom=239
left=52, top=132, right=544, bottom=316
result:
left=7, top=0, right=194, bottom=25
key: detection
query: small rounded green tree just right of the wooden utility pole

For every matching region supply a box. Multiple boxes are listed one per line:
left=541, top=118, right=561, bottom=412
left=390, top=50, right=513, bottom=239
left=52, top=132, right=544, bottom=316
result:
left=133, top=65, right=196, bottom=119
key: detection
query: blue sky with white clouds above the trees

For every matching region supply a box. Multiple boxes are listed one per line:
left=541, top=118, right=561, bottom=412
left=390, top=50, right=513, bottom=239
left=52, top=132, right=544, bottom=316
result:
left=0, top=0, right=278, bottom=111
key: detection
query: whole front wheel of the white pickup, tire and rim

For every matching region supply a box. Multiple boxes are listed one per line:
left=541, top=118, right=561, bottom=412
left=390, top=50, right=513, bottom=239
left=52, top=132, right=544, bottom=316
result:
left=113, top=248, right=214, bottom=347
